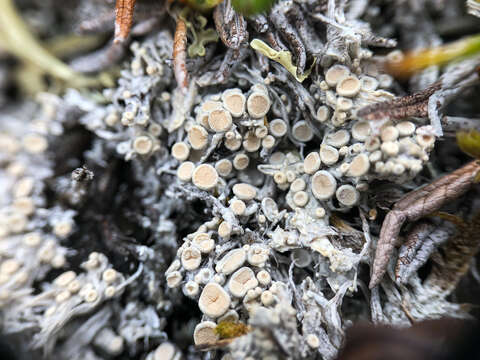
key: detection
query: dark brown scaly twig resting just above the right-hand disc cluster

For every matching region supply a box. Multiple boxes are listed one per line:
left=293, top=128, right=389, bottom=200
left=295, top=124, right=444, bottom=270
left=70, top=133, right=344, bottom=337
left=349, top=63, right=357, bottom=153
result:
left=357, top=82, right=441, bottom=120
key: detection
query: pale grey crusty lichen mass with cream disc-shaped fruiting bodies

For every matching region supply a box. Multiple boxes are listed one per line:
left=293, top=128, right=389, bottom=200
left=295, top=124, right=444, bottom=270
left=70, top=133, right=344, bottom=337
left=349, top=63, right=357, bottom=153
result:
left=0, top=0, right=479, bottom=360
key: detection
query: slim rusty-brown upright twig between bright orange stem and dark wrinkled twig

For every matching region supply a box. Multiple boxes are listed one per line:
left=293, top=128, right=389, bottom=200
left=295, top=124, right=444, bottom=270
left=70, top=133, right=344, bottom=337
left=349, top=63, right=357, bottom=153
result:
left=172, top=17, right=188, bottom=94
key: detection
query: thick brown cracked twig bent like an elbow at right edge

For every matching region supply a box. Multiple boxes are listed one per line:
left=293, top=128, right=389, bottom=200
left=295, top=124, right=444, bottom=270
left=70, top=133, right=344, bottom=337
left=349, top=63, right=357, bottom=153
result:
left=369, top=161, right=480, bottom=288
